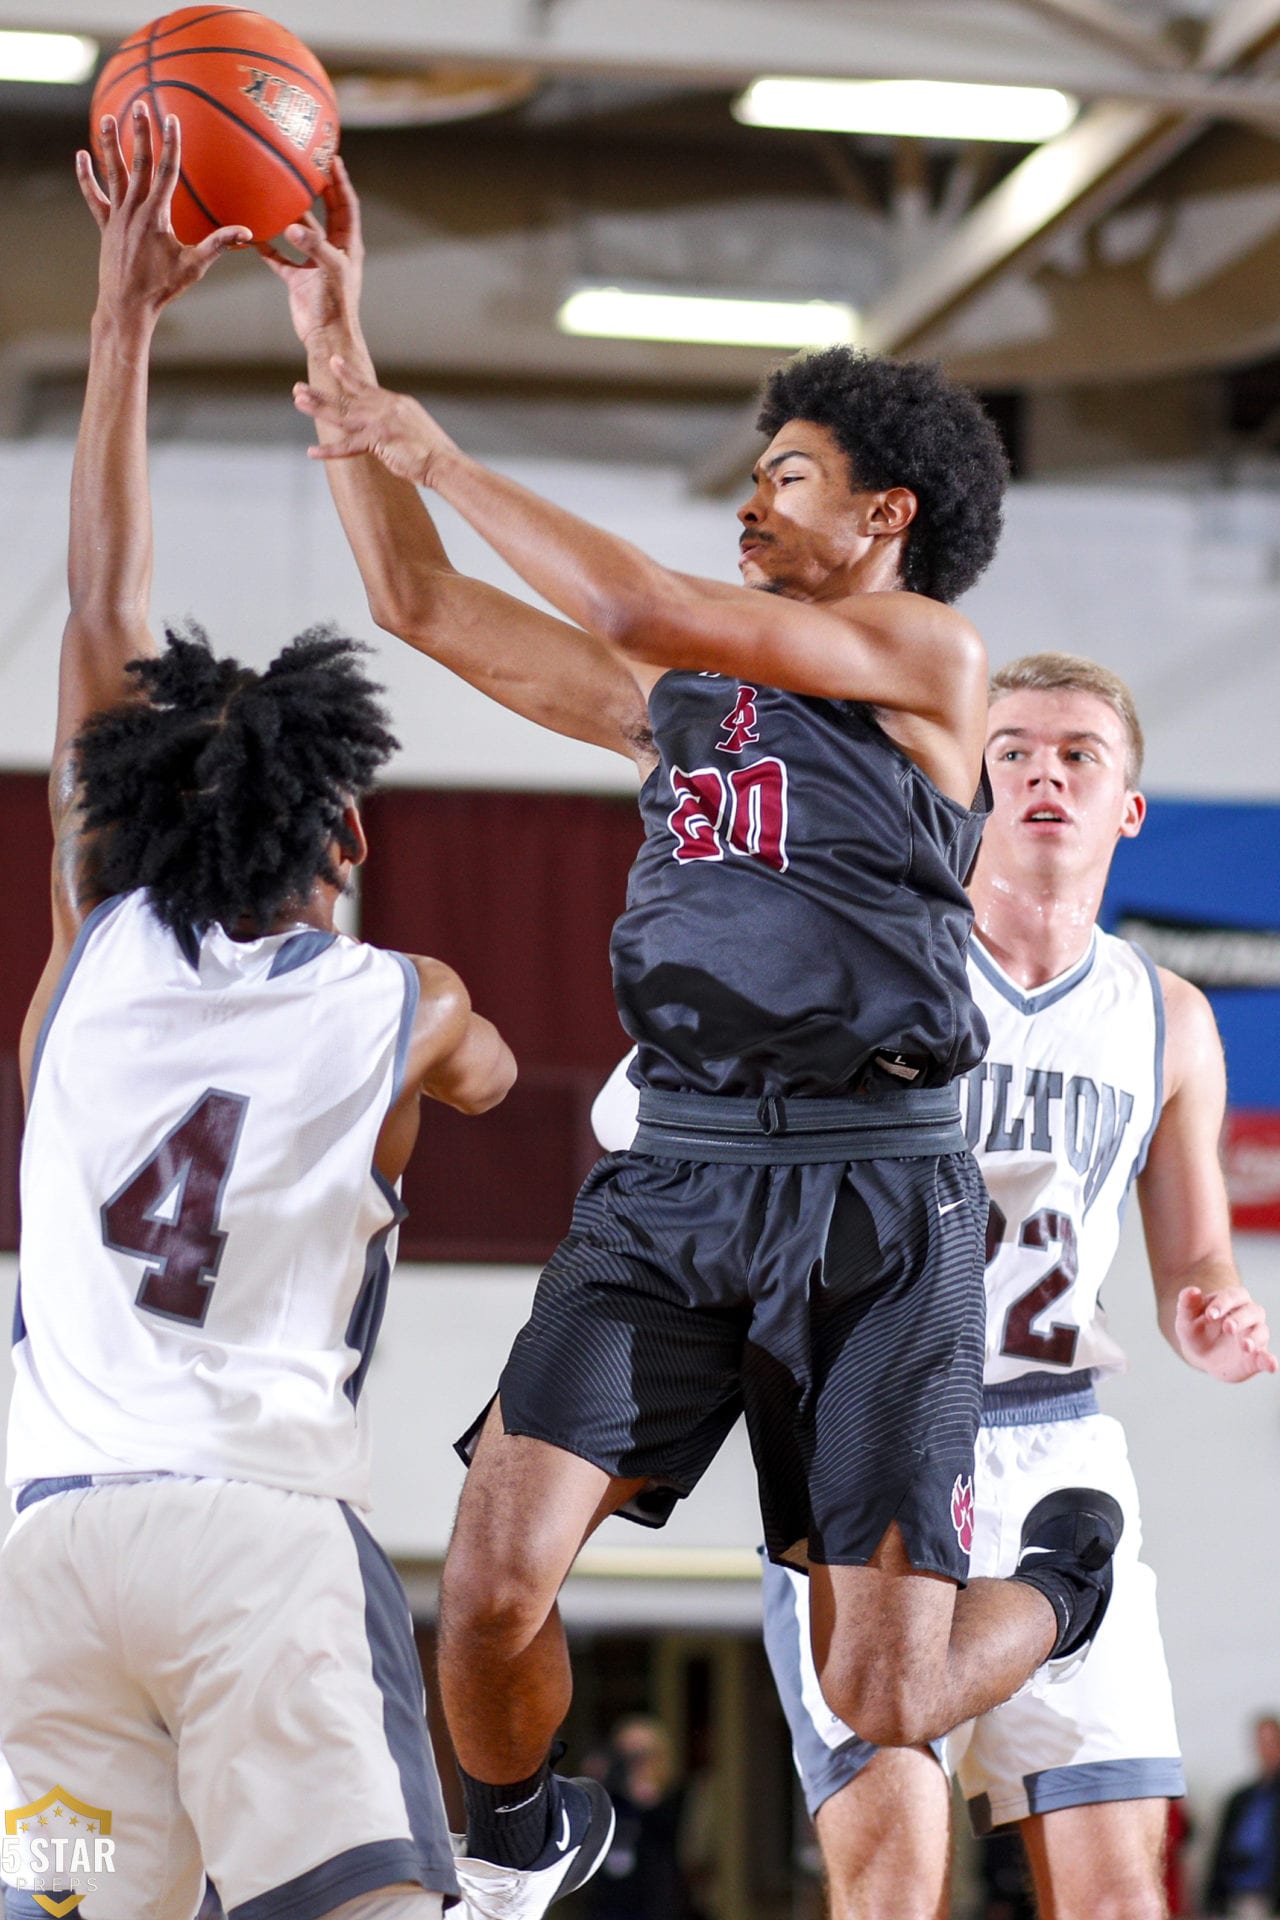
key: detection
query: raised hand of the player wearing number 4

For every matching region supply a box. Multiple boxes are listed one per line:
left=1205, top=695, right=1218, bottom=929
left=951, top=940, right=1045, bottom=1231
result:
left=75, top=102, right=253, bottom=319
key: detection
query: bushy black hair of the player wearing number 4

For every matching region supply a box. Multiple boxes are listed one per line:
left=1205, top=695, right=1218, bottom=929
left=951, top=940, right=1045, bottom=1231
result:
left=75, top=622, right=397, bottom=935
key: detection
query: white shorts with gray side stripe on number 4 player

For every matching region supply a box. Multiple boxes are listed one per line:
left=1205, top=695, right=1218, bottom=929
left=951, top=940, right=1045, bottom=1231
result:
left=0, top=1476, right=457, bottom=1920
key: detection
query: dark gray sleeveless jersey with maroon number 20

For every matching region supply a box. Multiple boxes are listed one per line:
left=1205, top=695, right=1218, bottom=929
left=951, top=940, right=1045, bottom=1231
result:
left=612, top=672, right=990, bottom=1096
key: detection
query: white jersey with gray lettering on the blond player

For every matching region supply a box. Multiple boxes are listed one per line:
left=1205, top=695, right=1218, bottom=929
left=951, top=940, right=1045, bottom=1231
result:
left=961, top=929, right=1165, bottom=1386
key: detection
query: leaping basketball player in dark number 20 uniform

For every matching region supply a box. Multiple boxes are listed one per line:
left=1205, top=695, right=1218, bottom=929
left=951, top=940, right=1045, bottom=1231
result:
left=280, top=175, right=1119, bottom=1920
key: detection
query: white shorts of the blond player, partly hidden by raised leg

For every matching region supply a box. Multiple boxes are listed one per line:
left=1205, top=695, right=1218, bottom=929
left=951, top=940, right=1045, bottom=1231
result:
left=764, top=1375, right=1186, bottom=1834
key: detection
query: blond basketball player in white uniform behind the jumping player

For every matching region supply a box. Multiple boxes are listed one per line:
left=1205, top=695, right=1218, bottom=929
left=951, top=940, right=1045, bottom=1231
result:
left=766, top=653, right=1276, bottom=1920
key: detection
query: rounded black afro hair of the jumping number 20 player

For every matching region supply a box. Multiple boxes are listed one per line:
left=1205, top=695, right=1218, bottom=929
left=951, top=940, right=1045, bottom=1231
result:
left=756, top=348, right=1009, bottom=601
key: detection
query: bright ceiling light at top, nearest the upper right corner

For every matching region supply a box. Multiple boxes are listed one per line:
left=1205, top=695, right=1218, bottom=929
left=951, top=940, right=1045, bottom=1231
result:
left=733, top=75, right=1080, bottom=146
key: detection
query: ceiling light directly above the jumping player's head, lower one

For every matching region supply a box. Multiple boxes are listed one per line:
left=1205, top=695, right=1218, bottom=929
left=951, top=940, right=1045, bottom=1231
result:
left=557, top=284, right=858, bottom=348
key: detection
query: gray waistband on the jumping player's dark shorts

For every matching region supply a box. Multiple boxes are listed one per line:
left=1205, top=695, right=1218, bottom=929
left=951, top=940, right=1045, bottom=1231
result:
left=633, top=1085, right=967, bottom=1165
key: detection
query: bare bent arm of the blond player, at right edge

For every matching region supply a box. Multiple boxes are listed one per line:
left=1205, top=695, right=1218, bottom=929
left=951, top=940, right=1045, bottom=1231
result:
left=1138, top=968, right=1280, bottom=1380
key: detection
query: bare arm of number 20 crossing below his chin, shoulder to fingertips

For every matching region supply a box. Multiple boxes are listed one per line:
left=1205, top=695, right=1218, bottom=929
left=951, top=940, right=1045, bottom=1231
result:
left=296, top=359, right=986, bottom=801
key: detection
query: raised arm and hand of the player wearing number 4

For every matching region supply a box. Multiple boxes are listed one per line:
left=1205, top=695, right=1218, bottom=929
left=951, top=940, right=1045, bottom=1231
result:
left=21, top=108, right=249, bottom=1098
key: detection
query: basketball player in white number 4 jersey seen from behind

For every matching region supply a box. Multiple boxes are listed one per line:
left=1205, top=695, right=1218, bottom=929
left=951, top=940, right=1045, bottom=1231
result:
left=0, top=109, right=514, bottom=1920
